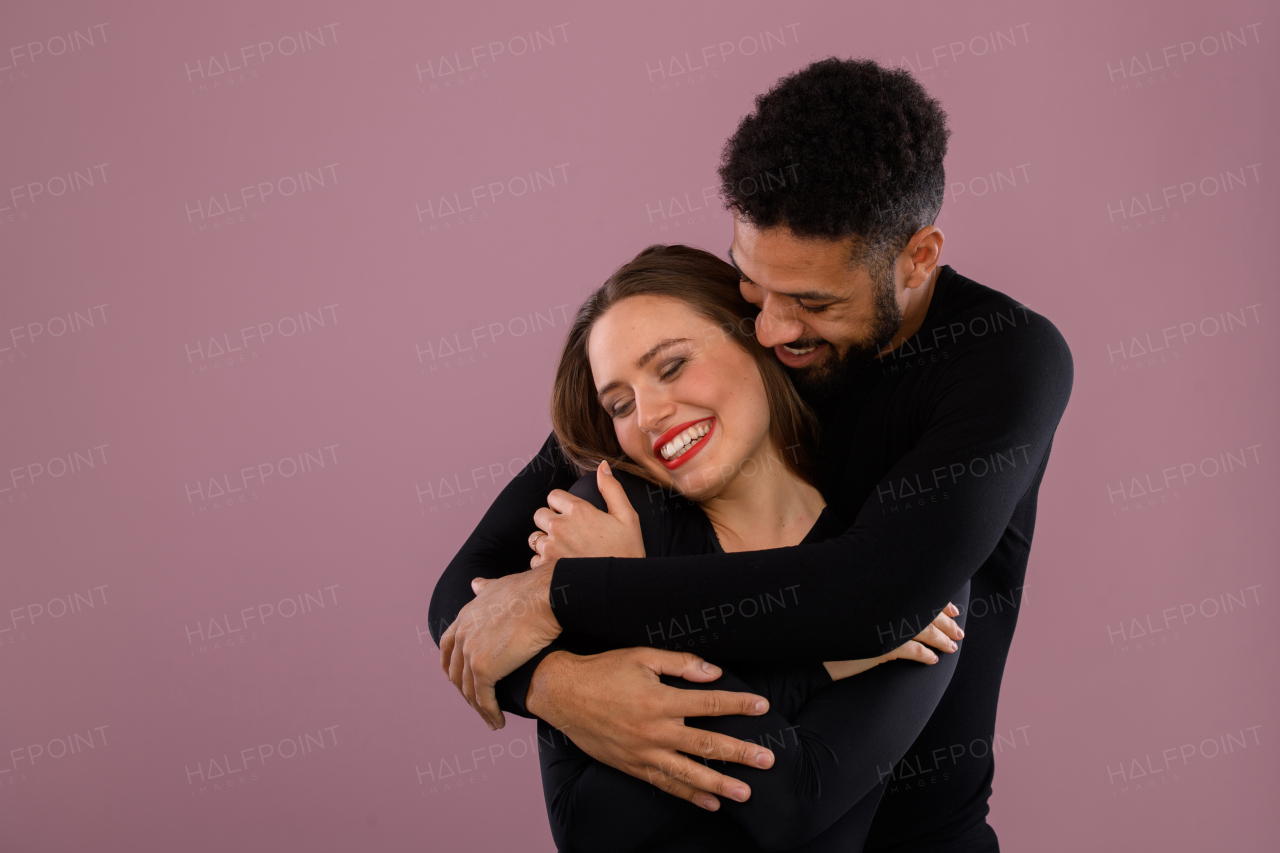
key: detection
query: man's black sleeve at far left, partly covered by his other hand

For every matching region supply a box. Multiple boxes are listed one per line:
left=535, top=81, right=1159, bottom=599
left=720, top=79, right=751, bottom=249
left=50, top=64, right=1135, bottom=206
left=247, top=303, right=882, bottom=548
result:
left=428, top=433, right=579, bottom=717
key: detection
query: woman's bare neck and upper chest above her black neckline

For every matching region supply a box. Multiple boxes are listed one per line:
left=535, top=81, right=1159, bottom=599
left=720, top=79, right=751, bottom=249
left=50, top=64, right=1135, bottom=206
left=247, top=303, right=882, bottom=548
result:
left=701, top=452, right=827, bottom=551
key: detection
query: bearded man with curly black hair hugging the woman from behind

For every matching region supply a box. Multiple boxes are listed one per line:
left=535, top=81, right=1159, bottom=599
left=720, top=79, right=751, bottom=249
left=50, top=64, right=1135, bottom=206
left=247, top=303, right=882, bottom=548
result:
left=430, top=58, right=1073, bottom=850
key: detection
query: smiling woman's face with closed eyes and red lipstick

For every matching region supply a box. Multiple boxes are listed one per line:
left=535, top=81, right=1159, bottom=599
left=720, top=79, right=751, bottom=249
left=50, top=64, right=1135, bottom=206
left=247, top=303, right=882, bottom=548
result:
left=588, top=296, right=781, bottom=500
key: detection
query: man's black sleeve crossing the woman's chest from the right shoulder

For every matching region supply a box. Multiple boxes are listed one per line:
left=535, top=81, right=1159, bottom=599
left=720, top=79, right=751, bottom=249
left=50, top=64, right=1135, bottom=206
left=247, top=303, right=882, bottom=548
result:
left=553, top=309, right=1073, bottom=661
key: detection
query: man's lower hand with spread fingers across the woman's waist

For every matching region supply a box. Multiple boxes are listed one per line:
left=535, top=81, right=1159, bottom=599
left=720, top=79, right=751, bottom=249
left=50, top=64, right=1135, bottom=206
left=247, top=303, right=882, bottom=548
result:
left=526, top=648, right=773, bottom=811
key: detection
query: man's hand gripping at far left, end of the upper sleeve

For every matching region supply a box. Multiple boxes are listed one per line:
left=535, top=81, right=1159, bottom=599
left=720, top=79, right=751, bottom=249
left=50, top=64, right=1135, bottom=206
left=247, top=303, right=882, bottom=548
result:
left=440, top=565, right=562, bottom=729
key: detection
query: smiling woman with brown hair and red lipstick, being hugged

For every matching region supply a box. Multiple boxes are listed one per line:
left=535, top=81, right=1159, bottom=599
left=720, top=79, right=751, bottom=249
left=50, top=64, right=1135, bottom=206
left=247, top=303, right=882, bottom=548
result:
left=531, top=246, right=968, bottom=852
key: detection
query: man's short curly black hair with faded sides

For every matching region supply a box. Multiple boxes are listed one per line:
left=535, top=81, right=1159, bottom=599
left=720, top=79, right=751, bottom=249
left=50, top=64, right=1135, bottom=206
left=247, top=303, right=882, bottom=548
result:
left=719, top=56, right=951, bottom=265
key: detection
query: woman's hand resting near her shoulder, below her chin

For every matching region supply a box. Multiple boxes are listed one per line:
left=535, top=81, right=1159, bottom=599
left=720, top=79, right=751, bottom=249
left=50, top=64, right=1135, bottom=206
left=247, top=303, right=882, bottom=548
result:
left=529, top=462, right=645, bottom=569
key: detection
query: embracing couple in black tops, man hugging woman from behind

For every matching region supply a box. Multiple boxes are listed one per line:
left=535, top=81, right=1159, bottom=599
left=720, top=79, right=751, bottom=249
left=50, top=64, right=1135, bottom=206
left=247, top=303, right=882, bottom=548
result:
left=430, top=58, right=1073, bottom=853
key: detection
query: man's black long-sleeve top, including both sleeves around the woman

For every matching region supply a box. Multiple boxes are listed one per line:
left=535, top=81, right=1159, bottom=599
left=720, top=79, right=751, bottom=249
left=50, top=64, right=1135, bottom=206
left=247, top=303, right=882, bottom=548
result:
left=430, top=266, right=1073, bottom=845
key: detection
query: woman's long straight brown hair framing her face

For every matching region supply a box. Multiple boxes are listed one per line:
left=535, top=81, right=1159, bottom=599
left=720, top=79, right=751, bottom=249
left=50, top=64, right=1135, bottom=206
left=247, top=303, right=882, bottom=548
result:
left=552, top=245, right=818, bottom=485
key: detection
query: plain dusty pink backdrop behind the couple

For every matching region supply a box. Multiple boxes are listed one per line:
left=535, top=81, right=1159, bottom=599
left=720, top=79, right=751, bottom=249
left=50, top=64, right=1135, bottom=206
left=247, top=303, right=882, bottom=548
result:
left=0, top=0, right=1280, bottom=853
